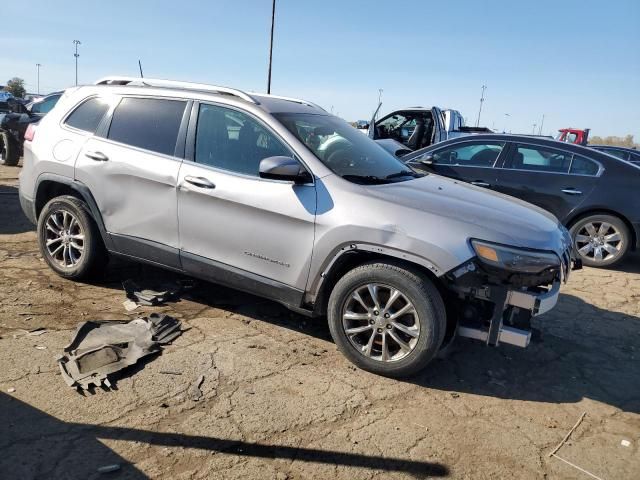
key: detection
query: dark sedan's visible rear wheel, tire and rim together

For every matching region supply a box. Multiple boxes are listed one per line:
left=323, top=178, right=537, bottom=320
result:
left=569, top=214, right=631, bottom=267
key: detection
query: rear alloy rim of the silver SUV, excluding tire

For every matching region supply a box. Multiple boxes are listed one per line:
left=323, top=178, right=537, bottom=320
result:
left=45, top=210, right=85, bottom=268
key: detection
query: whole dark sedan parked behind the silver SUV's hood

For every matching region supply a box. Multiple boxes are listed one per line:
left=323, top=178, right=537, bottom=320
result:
left=403, top=135, right=640, bottom=267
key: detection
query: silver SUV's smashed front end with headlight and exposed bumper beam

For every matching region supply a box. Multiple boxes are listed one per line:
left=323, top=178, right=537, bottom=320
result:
left=444, top=240, right=582, bottom=347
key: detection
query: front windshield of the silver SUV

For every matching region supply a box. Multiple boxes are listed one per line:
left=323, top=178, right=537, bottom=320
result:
left=274, top=113, right=421, bottom=184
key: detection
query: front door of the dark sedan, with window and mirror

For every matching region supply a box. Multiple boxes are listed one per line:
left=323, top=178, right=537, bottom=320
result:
left=417, top=140, right=505, bottom=188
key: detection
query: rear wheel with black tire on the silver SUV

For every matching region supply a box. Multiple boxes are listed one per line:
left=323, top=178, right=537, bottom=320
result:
left=38, top=195, right=109, bottom=280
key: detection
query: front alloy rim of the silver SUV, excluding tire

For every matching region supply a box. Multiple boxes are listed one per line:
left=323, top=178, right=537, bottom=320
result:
left=342, top=283, right=420, bottom=362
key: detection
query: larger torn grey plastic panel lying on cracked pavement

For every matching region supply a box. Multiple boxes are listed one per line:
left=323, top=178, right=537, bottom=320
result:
left=57, top=313, right=182, bottom=390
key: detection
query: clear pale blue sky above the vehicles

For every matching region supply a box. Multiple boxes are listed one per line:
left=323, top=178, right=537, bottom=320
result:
left=0, top=0, right=640, bottom=141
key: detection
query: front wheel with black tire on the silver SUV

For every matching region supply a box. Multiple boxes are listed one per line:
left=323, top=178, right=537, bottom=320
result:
left=327, top=262, right=446, bottom=377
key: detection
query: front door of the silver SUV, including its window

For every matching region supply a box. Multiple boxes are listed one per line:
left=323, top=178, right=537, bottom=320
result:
left=178, top=103, right=316, bottom=293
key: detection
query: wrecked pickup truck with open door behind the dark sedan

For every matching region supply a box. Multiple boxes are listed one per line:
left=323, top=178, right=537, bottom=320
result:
left=367, top=104, right=491, bottom=157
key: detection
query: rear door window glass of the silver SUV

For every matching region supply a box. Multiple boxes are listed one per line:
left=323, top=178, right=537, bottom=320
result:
left=107, top=98, right=186, bottom=155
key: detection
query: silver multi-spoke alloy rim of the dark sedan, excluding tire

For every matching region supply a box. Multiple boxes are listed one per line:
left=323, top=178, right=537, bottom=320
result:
left=574, top=222, right=623, bottom=262
